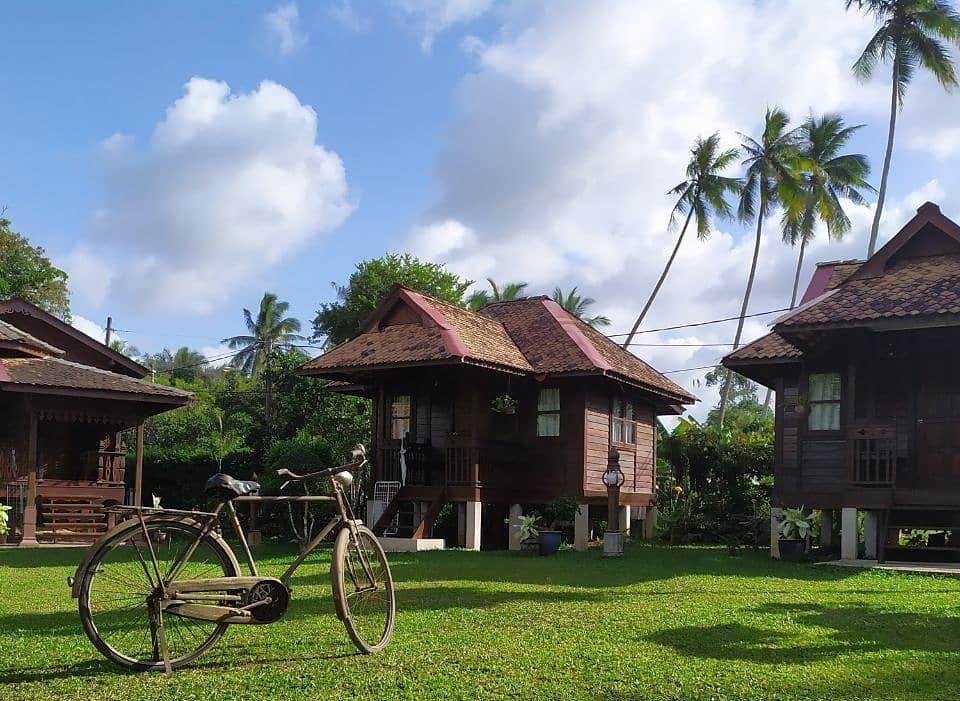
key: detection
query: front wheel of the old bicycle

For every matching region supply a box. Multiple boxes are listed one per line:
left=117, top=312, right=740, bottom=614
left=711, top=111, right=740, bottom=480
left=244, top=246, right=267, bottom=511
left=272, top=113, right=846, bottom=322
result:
left=330, top=526, right=397, bottom=654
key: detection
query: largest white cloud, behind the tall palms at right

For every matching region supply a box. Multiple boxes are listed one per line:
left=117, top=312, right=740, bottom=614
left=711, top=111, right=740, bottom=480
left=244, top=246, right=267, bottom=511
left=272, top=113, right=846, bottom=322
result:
left=407, top=0, right=951, bottom=415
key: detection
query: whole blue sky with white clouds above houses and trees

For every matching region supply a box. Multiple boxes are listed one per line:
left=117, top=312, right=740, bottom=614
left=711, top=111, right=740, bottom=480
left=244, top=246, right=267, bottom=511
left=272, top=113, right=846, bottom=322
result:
left=0, top=0, right=960, bottom=416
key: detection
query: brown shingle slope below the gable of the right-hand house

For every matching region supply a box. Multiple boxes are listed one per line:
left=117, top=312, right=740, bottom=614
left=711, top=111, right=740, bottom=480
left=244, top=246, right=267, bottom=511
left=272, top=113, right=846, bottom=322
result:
left=777, top=254, right=960, bottom=329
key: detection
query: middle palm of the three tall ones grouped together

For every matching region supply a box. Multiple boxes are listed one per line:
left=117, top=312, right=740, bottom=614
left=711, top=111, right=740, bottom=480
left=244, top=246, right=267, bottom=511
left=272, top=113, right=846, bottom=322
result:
left=718, top=107, right=800, bottom=428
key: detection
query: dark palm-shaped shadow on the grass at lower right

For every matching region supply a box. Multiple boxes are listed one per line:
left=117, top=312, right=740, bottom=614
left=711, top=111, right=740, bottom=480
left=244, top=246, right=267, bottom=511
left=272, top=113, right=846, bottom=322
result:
left=646, top=603, right=960, bottom=665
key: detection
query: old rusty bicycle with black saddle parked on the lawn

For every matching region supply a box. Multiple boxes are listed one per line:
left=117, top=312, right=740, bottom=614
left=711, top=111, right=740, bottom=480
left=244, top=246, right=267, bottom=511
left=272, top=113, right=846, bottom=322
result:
left=68, top=446, right=396, bottom=672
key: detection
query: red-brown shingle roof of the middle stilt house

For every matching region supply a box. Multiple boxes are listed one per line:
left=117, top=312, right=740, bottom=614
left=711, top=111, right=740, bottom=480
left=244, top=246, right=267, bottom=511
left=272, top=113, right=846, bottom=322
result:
left=303, top=288, right=696, bottom=403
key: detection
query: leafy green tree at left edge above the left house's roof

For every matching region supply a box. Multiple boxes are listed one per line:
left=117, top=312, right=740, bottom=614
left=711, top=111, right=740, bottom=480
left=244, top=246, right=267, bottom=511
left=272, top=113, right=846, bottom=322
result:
left=0, top=212, right=70, bottom=321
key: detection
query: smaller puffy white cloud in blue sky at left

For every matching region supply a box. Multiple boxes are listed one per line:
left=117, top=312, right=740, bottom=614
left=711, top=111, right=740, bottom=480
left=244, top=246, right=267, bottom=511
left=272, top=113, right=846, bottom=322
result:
left=74, top=78, right=352, bottom=312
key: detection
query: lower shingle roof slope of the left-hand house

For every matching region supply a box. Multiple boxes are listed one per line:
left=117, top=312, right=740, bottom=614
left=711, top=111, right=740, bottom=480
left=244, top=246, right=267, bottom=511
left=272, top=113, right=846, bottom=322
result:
left=0, top=357, right=191, bottom=404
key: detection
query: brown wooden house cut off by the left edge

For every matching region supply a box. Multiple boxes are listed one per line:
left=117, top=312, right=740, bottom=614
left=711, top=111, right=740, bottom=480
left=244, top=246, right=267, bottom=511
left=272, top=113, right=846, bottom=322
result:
left=0, top=299, right=190, bottom=545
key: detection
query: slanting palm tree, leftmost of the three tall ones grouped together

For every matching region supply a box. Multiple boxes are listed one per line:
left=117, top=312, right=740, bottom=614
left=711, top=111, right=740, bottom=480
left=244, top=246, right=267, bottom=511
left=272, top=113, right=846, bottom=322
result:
left=623, top=132, right=740, bottom=348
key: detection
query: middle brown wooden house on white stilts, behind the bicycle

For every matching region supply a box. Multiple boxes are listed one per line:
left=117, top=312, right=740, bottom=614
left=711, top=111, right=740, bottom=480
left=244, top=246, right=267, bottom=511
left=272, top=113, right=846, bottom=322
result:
left=302, top=287, right=695, bottom=548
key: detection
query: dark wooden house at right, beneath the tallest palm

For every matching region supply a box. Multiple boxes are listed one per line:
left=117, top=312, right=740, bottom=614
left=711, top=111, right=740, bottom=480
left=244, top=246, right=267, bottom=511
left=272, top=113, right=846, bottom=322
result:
left=723, top=202, right=960, bottom=559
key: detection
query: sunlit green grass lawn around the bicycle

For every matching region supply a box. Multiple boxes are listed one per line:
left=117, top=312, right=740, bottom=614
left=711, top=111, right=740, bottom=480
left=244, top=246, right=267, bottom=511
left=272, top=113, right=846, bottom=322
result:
left=0, top=546, right=960, bottom=701
